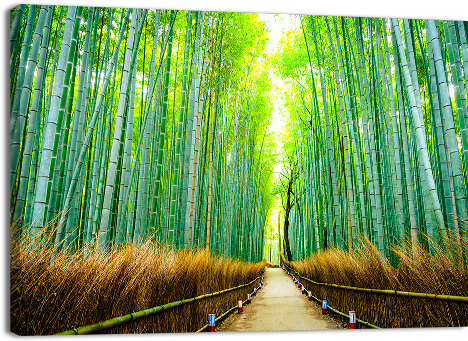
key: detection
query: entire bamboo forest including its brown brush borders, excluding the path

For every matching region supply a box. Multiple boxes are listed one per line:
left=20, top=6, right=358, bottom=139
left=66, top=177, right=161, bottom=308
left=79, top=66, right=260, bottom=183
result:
left=9, top=4, right=468, bottom=335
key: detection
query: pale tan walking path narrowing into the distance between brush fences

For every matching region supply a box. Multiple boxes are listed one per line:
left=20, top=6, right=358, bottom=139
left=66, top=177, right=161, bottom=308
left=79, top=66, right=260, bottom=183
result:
left=216, top=268, right=343, bottom=332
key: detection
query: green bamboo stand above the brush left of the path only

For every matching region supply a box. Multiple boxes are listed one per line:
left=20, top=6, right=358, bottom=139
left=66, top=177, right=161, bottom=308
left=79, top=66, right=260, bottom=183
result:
left=10, top=5, right=273, bottom=262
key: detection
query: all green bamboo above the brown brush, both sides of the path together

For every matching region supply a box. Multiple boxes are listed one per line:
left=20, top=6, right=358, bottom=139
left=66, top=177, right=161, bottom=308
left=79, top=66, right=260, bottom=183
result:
left=10, top=5, right=468, bottom=265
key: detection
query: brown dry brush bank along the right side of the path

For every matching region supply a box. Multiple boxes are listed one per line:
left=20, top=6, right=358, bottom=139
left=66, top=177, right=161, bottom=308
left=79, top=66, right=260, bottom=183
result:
left=281, top=234, right=468, bottom=328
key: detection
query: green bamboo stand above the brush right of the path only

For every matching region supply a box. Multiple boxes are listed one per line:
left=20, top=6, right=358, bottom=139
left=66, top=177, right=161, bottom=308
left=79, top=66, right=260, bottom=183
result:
left=276, top=15, right=468, bottom=268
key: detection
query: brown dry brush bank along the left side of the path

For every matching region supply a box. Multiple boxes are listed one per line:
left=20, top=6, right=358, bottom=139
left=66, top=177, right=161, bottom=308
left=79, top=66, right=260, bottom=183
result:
left=10, top=223, right=265, bottom=335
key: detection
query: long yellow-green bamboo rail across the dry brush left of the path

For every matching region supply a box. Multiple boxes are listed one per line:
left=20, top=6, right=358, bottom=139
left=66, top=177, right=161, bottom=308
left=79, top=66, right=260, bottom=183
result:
left=52, top=269, right=265, bottom=336
